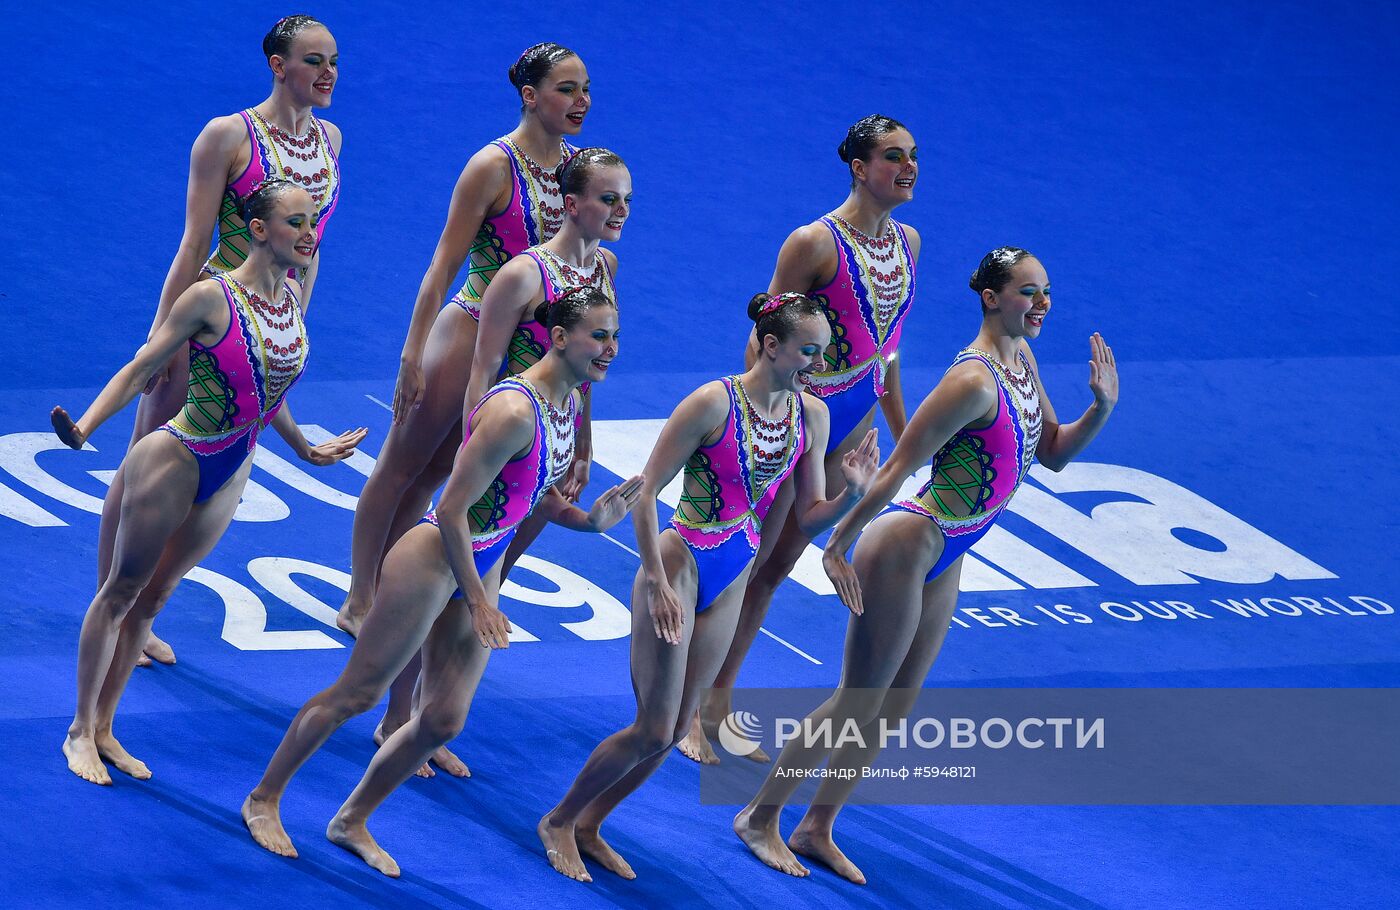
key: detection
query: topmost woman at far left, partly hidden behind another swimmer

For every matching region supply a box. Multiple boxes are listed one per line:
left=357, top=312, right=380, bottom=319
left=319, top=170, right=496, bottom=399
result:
left=98, top=15, right=340, bottom=665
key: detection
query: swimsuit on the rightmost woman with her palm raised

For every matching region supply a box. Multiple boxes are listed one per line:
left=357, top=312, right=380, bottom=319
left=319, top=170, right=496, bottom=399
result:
left=890, top=347, right=1044, bottom=584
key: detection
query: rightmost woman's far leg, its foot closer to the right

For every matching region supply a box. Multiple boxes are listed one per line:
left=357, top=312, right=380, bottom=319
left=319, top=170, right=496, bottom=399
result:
left=788, top=559, right=962, bottom=885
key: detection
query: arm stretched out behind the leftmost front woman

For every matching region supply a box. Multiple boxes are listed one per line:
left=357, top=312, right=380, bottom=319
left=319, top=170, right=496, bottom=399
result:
left=50, top=281, right=228, bottom=448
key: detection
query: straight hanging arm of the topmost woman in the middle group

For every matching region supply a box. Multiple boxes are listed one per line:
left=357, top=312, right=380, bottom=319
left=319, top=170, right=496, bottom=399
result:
left=393, top=146, right=510, bottom=423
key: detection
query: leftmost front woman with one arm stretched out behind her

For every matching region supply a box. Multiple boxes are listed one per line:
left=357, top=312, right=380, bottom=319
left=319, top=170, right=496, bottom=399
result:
left=53, top=181, right=365, bottom=784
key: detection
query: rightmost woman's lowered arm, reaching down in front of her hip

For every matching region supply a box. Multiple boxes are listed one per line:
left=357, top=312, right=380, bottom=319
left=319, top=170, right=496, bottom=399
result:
left=822, top=364, right=997, bottom=615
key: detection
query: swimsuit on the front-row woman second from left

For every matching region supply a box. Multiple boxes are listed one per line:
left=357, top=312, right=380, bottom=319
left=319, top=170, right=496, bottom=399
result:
left=420, top=377, right=578, bottom=582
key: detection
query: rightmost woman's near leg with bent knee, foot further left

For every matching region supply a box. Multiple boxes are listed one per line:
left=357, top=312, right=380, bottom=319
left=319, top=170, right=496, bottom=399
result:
left=734, top=512, right=942, bottom=875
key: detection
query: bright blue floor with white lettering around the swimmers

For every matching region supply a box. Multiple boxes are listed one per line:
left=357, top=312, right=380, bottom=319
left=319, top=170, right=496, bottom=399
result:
left=0, top=0, right=1400, bottom=909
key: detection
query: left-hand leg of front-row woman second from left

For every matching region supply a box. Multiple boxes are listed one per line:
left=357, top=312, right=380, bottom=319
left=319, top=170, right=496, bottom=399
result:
left=242, top=525, right=456, bottom=857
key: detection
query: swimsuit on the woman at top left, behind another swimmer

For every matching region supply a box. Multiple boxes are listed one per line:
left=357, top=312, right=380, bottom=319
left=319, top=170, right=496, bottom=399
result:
left=202, top=108, right=340, bottom=280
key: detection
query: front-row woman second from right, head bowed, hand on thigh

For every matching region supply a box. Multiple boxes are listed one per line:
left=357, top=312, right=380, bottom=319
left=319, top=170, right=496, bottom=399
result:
left=538, top=294, right=879, bottom=882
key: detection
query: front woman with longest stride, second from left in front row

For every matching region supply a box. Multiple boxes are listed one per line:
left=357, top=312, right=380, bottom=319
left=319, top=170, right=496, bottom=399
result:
left=242, top=288, right=643, bottom=876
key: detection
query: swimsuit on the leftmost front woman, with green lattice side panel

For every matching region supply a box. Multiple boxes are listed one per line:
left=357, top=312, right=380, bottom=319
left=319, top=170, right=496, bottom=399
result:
left=161, top=274, right=309, bottom=503
